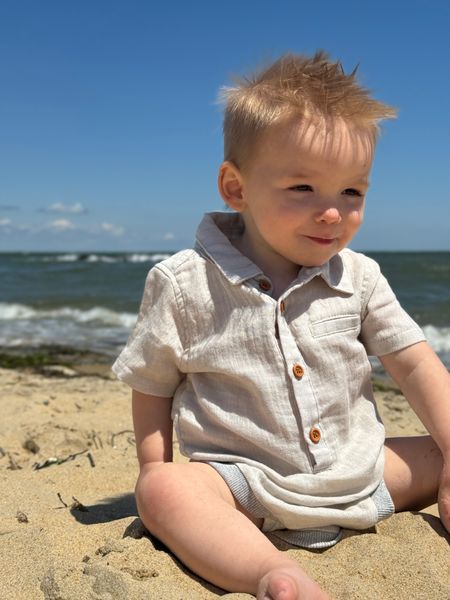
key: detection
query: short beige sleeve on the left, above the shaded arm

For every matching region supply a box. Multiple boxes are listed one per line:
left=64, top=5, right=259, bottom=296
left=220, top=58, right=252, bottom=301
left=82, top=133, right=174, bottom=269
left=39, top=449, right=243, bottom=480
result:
left=112, top=265, right=185, bottom=398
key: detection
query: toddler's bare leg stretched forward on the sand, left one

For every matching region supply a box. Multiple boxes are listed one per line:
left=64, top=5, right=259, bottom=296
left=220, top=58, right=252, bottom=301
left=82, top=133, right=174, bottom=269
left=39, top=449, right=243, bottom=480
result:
left=136, top=462, right=329, bottom=600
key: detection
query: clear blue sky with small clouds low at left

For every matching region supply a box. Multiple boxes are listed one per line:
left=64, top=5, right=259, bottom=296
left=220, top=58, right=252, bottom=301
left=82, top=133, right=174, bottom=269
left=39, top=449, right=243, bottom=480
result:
left=0, top=0, right=450, bottom=251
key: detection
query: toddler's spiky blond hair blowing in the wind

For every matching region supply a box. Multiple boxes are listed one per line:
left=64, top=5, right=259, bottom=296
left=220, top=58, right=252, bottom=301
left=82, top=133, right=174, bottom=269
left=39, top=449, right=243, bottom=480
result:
left=219, top=51, right=396, bottom=168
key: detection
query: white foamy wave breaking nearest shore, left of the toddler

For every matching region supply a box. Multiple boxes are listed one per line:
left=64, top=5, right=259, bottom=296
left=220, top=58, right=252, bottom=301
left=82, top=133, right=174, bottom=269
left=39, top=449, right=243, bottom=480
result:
left=0, top=302, right=136, bottom=329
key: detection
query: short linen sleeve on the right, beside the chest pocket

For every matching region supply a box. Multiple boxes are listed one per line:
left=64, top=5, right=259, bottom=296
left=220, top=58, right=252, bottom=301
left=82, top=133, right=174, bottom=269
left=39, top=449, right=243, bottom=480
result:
left=360, top=261, right=425, bottom=356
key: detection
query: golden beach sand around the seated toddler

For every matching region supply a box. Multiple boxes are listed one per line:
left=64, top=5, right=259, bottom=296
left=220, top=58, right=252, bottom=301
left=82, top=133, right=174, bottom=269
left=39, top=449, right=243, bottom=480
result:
left=0, top=369, right=450, bottom=600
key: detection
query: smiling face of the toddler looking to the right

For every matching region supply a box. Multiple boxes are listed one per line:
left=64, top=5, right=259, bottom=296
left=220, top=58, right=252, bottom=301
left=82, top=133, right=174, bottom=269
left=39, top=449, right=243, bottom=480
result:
left=227, top=121, right=373, bottom=275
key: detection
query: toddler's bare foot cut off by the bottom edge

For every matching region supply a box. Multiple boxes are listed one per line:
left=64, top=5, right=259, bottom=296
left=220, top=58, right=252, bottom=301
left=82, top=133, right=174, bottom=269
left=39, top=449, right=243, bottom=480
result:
left=256, top=563, right=330, bottom=600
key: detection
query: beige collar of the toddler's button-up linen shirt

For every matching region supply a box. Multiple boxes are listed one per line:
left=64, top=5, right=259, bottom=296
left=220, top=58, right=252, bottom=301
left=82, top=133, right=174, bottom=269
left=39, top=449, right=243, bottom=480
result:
left=195, top=212, right=354, bottom=294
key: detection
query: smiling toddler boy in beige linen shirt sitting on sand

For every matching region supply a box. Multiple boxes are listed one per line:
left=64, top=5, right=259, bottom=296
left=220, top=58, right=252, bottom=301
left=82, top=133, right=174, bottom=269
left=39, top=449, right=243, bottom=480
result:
left=113, top=52, right=450, bottom=600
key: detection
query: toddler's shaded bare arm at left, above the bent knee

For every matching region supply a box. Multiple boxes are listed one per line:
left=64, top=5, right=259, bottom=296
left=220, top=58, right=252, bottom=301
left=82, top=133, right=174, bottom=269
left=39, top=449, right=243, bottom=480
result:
left=132, top=390, right=172, bottom=469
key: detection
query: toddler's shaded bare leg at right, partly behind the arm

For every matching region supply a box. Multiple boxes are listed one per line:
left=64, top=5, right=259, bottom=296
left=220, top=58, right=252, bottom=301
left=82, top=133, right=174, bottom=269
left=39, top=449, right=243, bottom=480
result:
left=384, top=435, right=443, bottom=512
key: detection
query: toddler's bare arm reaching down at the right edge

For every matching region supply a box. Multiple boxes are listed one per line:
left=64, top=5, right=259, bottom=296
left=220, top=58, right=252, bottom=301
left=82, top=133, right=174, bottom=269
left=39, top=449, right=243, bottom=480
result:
left=380, top=342, right=450, bottom=531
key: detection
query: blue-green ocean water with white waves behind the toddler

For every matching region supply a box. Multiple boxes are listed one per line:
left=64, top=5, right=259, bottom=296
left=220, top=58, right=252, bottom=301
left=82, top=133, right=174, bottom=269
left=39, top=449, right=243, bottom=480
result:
left=0, top=252, right=450, bottom=368
